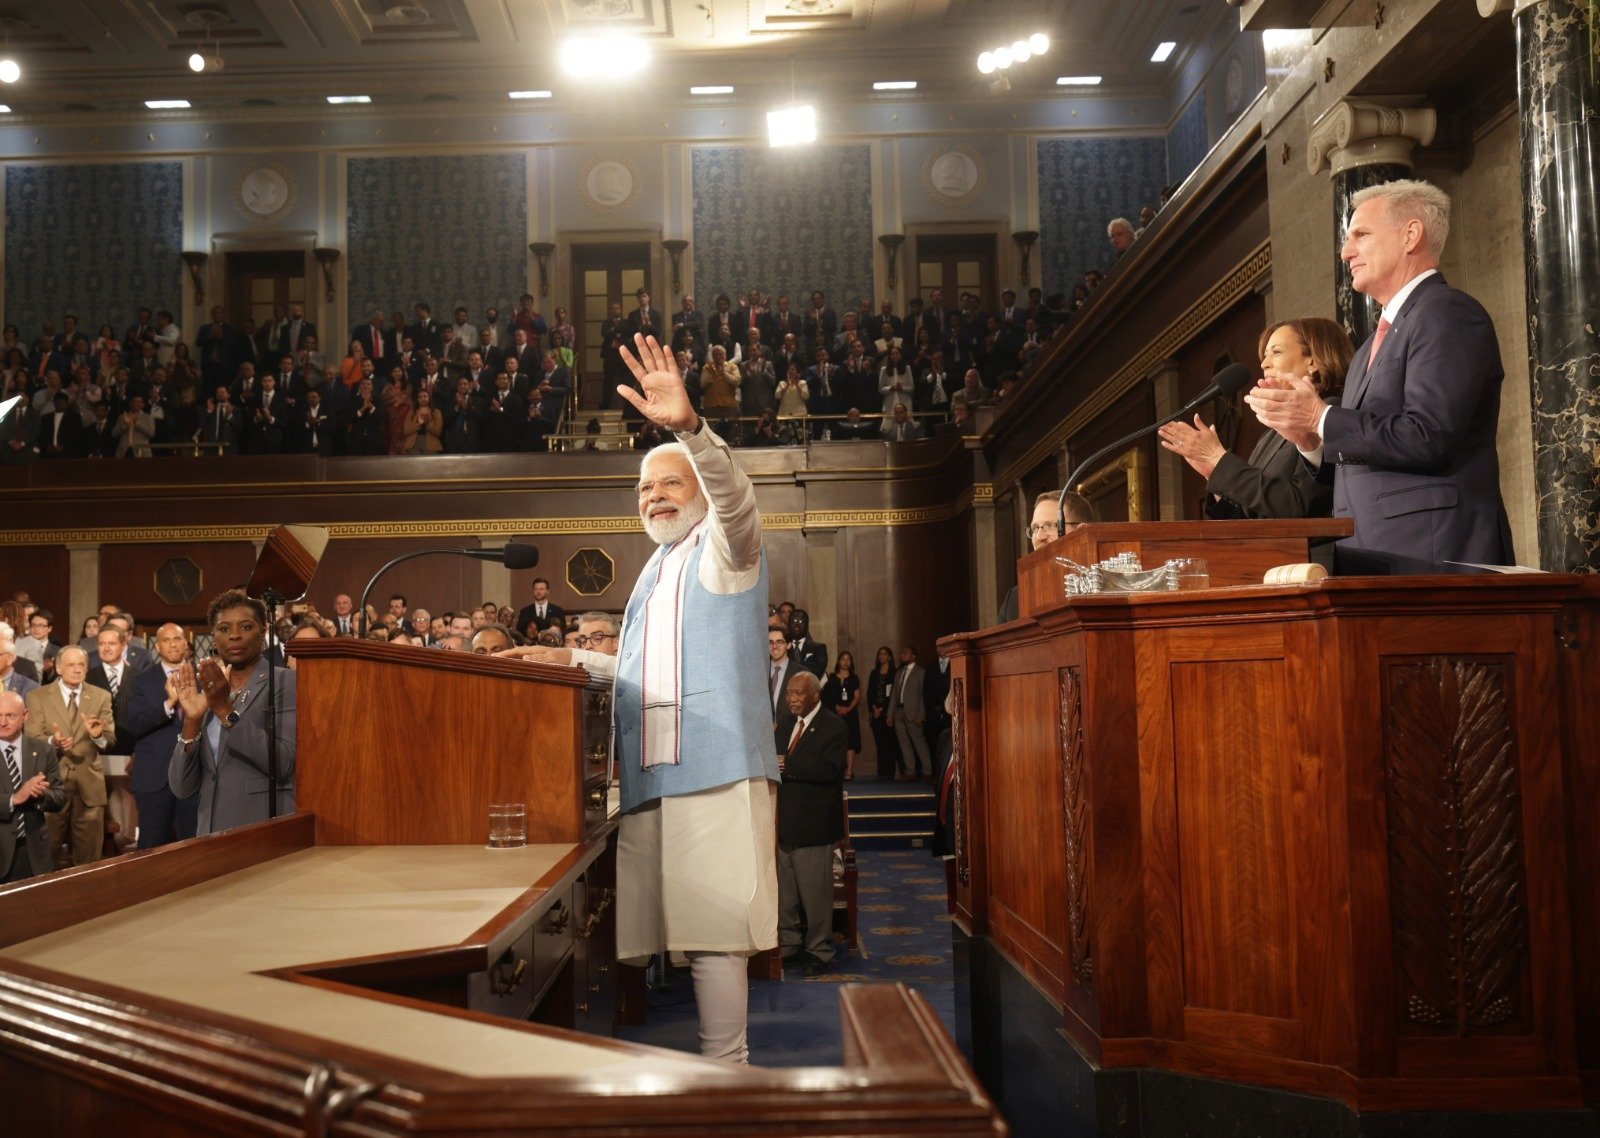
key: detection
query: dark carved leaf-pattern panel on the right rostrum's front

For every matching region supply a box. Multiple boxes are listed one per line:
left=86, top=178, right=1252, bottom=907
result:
left=1382, top=656, right=1528, bottom=1037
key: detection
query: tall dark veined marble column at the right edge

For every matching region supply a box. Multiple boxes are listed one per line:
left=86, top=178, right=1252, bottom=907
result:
left=1515, top=0, right=1600, bottom=573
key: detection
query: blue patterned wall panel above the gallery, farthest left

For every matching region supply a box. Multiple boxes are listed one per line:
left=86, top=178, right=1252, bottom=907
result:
left=5, top=162, right=184, bottom=341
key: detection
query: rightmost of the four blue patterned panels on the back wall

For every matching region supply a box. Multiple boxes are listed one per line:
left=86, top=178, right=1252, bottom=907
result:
left=1038, top=138, right=1166, bottom=296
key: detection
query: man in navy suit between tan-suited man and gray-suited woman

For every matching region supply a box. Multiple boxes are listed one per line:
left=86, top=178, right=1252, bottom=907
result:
left=125, top=624, right=200, bottom=850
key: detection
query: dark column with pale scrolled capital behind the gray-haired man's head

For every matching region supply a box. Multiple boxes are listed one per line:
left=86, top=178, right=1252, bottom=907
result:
left=1312, top=99, right=1438, bottom=344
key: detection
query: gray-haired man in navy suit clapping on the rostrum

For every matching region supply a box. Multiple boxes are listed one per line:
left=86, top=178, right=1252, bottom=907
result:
left=1245, top=181, right=1514, bottom=573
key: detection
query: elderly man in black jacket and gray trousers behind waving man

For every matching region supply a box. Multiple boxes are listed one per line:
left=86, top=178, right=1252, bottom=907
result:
left=773, top=672, right=850, bottom=976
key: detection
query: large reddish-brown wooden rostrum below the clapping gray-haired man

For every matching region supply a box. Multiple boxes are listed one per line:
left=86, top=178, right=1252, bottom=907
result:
left=941, top=523, right=1600, bottom=1111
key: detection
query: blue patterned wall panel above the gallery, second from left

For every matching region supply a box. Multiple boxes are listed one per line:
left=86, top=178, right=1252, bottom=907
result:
left=346, top=154, right=528, bottom=328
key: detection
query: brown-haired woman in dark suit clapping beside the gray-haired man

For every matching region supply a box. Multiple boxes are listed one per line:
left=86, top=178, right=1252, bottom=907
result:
left=1158, top=317, right=1355, bottom=519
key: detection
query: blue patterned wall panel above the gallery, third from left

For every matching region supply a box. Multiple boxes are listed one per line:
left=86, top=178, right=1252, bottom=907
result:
left=691, top=146, right=874, bottom=312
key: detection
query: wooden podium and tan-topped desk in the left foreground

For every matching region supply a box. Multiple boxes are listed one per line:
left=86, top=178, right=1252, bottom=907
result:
left=0, top=640, right=1005, bottom=1138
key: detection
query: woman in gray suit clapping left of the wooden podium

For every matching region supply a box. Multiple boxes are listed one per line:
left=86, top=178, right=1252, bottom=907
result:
left=166, top=589, right=294, bottom=835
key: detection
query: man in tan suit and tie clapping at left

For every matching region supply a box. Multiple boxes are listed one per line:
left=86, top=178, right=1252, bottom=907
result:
left=26, top=645, right=115, bottom=866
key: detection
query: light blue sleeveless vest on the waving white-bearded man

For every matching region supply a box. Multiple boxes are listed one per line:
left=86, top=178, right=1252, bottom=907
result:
left=613, top=528, right=779, bottom=813
